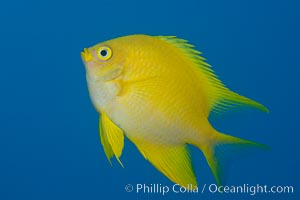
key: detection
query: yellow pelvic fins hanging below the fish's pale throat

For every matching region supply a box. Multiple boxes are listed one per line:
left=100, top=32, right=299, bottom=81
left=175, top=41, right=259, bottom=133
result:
left=99, top=113, right=124, bottom=167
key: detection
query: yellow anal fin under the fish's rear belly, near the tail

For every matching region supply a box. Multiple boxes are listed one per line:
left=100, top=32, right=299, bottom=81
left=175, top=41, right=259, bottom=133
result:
left=135, top=143, right=197, bottom=187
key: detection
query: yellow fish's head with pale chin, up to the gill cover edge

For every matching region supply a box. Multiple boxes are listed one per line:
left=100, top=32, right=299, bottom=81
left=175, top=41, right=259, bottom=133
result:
left=81, top=40, right=128, bottom=111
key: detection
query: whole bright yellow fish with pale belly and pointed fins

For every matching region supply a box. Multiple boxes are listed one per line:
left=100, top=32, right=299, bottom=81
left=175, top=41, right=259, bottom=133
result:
left=81, top=35, right=268, bottom=186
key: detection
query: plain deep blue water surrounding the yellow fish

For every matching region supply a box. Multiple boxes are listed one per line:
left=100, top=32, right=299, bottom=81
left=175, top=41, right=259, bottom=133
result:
left=0, top=0, right=300, bottom=200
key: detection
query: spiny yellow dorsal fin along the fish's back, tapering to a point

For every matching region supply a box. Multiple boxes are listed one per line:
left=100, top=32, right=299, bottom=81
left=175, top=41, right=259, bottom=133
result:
left=156, top=36, right=268, bottom=113
